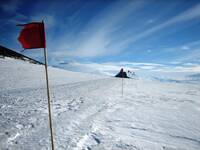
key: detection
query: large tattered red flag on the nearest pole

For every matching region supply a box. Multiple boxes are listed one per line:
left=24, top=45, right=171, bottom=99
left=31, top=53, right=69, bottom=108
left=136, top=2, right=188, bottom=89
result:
left=18, top=22, right=46, bottom=49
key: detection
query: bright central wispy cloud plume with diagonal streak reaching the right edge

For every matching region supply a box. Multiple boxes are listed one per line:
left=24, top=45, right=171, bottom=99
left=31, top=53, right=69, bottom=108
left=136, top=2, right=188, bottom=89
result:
left=55, top=1, right=200, bottom=57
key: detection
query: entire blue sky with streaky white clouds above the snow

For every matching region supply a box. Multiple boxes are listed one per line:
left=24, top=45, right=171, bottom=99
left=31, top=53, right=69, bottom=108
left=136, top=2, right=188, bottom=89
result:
left=0, top=0, right=200, bottom=74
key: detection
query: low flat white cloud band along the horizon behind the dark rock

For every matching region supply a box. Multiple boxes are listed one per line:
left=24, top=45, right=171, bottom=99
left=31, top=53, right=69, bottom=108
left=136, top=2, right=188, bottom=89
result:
left=60, top=61, right=200, bottom=76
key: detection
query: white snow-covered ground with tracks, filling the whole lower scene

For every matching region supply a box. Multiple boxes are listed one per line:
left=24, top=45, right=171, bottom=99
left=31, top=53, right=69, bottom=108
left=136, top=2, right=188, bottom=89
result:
left=0, top=58, right=200, bottom=150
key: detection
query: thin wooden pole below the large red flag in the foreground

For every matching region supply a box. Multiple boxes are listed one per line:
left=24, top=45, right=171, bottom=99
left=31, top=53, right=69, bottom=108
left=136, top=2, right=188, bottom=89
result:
left=44, top=48, right=55, bottom=150
